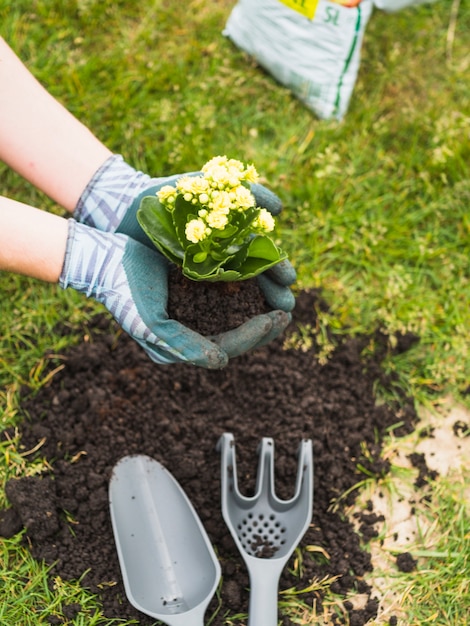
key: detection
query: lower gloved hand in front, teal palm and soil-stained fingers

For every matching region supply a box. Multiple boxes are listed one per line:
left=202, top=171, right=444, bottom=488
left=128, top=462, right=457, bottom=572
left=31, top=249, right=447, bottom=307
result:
left=59, top=219, right=289, bottom=369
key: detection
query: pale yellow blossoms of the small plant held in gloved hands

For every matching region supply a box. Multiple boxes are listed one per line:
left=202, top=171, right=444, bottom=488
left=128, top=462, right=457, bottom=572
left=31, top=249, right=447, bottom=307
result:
left=157, top=156, right=274, bottom=243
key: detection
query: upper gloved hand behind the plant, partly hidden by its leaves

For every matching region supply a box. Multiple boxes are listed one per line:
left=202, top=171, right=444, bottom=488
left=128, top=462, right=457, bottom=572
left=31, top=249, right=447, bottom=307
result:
left=74, top=155, right=296, bottom=310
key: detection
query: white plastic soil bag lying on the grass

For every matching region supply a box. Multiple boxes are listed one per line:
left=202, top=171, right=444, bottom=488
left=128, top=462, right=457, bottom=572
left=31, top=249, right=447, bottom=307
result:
left=223, top=0, right=373, bottom=119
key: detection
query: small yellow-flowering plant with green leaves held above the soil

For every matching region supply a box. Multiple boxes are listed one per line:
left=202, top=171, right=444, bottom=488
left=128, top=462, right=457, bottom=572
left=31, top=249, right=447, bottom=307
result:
left=137, top=156, right=286, bottom=282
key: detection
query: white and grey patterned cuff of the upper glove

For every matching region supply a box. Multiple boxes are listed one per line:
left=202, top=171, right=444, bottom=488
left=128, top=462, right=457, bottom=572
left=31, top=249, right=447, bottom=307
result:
left=74, top=154, right=151, bottom=232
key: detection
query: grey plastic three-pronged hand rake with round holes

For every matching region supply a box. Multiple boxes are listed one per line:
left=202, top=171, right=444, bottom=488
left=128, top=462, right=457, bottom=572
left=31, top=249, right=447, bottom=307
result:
left=217, top=433, right=313, bottom=626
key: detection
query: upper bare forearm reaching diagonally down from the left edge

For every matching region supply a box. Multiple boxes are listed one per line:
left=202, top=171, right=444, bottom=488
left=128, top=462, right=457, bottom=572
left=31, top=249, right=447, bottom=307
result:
left=0, top=37, right=111, bottom=211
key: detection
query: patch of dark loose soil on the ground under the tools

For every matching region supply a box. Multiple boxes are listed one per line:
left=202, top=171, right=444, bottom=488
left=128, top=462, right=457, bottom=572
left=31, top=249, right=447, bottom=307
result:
left=0, top=291, right=417, bottom=626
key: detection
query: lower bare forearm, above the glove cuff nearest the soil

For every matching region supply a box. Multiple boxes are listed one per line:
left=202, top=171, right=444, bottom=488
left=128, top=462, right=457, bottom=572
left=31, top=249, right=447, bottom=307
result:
left=0, top=196, right=68, bottom=283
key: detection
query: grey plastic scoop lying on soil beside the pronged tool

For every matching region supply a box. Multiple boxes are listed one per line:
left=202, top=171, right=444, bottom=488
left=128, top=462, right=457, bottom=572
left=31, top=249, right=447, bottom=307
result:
left=109, top=455, right=221, bottom=626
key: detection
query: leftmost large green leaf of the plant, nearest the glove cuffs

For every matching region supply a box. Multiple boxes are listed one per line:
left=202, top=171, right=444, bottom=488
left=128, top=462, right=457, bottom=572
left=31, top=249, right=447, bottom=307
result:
left=137, top=196, right=184, bottom=265
